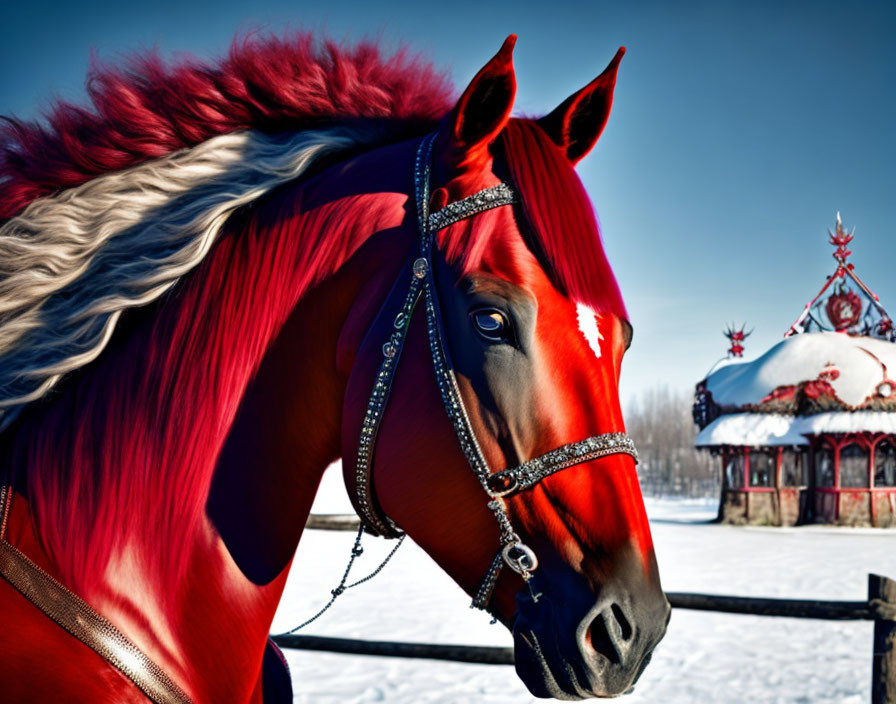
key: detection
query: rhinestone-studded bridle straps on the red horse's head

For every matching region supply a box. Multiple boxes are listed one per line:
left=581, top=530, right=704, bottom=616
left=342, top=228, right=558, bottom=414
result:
left=352, top=134, right=638, bottom=609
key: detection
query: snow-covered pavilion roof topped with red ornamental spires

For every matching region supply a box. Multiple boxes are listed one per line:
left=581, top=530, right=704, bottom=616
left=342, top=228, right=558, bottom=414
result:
left=694, top=213, right=896, bottom=446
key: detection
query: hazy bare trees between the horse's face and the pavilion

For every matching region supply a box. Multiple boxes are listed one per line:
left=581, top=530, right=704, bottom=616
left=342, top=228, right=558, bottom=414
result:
left=625, top=385, right=720, bottom=497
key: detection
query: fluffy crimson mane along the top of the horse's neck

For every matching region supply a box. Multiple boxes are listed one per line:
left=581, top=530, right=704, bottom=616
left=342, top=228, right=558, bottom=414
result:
left=0, top=33, right=452, bottom=220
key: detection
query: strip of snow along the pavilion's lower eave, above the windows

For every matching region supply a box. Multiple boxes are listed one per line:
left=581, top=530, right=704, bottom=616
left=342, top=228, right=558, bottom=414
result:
left=696, top=411, right=896, bottom=447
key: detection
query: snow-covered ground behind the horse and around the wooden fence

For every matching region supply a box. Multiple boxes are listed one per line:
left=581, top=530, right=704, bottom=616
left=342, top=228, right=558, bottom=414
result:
left=274, top=470, right=896, bottom=704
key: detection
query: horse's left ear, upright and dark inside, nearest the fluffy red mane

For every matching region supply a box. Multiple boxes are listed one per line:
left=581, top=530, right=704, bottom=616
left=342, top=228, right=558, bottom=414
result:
left=447, top=34, right=516, bottom=166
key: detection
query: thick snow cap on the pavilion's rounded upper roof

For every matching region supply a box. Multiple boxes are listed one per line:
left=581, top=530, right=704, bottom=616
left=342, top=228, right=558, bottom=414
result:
left=707, top=332, right=896, bottom=407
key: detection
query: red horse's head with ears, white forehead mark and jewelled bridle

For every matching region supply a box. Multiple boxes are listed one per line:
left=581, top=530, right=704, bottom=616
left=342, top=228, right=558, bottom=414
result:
left=343, top=37, right=669, bottom=699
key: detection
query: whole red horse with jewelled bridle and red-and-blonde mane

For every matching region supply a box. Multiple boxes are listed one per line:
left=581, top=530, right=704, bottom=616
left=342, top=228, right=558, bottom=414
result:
left=0, top=35, right=670, bottom=704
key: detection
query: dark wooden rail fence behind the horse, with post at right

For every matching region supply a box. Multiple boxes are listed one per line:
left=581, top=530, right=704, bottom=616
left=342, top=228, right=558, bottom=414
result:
left=274, top=515, right=896, bottom=704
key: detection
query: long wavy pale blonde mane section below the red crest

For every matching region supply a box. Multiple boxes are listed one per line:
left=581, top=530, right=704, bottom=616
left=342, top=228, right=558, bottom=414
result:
left=0, top=127, right=380, bottom=428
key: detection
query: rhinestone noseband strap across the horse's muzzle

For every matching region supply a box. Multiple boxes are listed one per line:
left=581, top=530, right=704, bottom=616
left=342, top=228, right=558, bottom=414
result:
left=487, top=433, right=638, bottom=496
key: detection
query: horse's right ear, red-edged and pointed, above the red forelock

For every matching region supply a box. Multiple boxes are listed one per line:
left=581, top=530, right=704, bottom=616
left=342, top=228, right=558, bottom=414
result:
left=538, top=46, right=625, bottom=164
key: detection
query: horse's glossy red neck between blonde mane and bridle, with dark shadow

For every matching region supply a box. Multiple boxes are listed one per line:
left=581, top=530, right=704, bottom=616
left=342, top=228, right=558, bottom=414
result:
left=4, top=136, right=413, bottom=701
